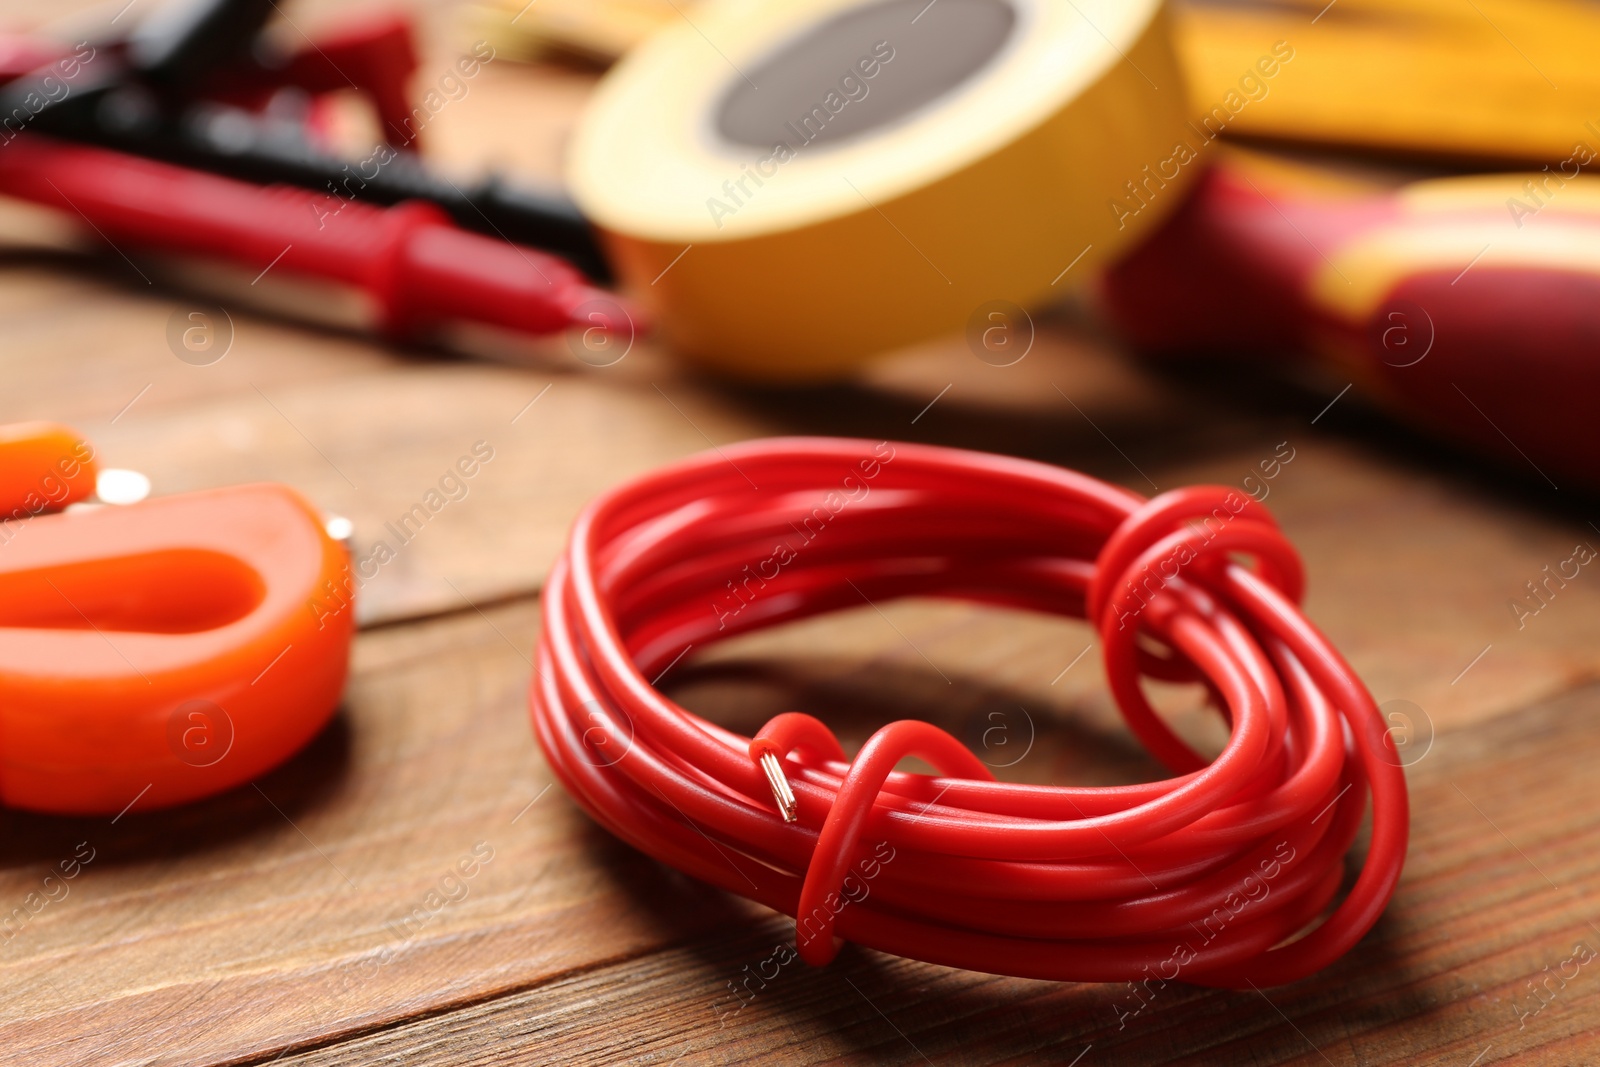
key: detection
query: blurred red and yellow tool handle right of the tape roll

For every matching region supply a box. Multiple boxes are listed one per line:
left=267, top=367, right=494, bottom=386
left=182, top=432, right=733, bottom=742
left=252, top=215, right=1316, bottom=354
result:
left=1101, top=154, right=1600, bottom=488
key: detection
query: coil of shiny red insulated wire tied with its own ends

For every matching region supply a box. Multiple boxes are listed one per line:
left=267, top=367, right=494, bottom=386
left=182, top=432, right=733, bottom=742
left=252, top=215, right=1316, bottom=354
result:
left=531, top=438, right=1408, bottom=987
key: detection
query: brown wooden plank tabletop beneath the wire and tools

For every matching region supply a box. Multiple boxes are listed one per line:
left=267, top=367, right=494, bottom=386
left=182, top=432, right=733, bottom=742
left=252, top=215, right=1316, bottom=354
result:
left=0, top=3, right=1600, bottom=1067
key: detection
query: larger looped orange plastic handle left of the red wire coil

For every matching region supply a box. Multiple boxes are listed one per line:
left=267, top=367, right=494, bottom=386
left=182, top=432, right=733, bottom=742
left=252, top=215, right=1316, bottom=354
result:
left=0, top=479, right=354, bottom=814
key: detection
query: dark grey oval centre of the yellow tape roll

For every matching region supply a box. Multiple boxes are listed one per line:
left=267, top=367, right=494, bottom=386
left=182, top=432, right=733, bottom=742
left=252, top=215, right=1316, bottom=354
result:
left=715, top=0, right=1018, bottom=151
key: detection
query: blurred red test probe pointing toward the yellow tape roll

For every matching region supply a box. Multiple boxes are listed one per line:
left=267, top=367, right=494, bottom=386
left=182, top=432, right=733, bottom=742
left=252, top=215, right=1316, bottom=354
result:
left=0, top=133, right=634, bottom=338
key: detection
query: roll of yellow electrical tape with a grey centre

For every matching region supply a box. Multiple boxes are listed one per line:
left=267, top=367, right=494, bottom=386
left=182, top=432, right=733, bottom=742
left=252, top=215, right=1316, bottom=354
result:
left=570, top=0, right=1198, bottom=381
